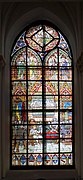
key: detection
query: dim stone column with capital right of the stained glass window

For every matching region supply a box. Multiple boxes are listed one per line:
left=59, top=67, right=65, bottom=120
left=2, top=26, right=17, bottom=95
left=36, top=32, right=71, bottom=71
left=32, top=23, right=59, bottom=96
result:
left=77, top=52, right=83, bottom=180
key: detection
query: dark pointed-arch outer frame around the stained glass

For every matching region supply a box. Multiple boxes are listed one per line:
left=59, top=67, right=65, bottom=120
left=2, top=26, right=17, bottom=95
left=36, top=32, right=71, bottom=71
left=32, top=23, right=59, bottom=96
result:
left=10, top=20, right=75, bottom=170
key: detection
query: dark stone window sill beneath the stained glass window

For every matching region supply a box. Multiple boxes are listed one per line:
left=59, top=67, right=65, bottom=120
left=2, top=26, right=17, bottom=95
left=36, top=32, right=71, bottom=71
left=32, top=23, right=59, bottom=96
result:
left=6, top=169, right=78, bottom=180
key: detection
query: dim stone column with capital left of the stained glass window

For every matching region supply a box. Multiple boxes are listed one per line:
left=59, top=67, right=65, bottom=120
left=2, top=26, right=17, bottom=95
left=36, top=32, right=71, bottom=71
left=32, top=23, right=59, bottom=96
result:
left=0, top=55, right=5, bottom=179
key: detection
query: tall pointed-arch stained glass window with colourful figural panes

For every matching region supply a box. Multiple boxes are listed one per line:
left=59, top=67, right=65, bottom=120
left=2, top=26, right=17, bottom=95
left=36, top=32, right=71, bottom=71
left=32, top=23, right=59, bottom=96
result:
left=10, top=21, right=74, bottom=169
